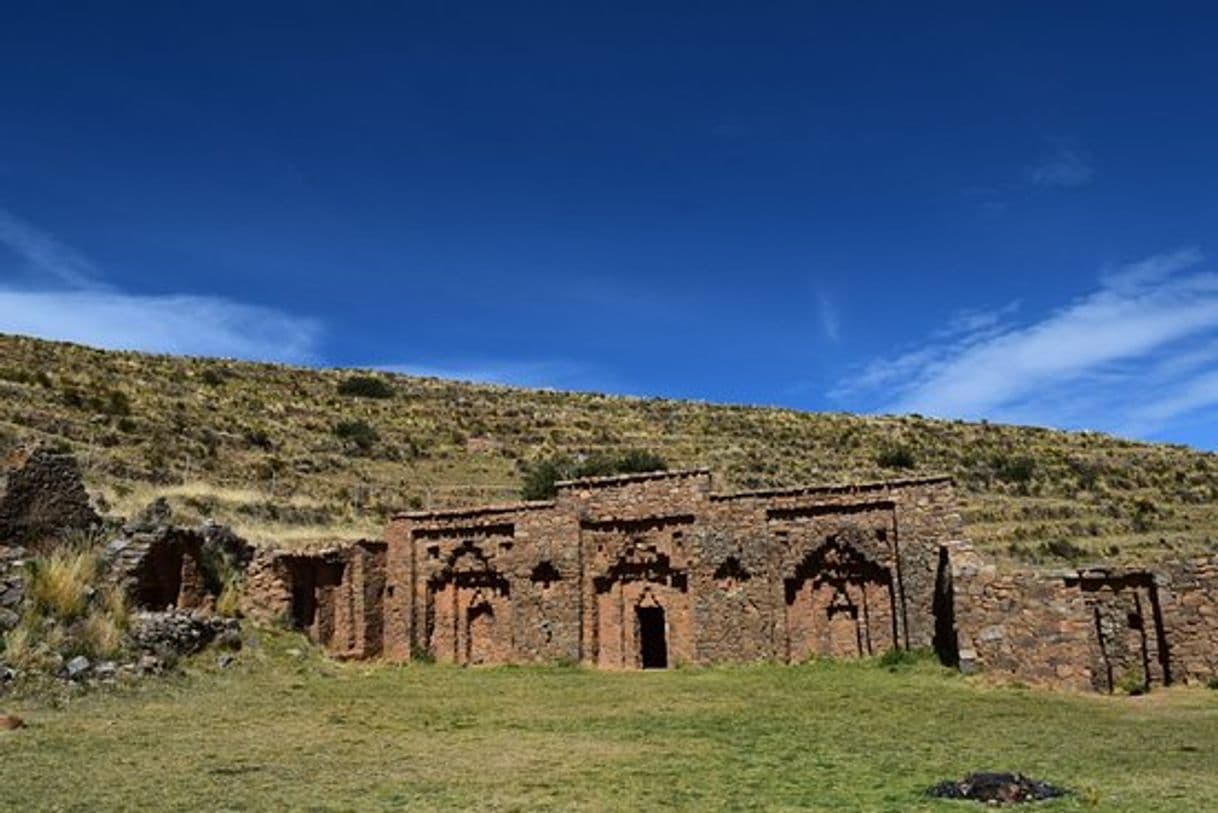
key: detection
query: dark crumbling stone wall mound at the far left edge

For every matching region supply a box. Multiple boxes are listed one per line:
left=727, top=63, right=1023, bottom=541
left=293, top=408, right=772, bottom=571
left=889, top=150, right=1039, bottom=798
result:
left=0, top=445, right=101, bottom=552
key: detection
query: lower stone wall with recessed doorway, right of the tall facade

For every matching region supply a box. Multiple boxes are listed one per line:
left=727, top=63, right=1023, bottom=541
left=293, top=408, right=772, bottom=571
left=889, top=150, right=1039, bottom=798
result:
left=950, top=546, right=1218, bottom=692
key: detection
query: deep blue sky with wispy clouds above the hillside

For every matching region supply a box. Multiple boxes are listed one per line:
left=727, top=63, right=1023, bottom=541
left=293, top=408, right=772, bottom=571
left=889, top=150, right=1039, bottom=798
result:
left=0, top=2, right=1218, bottom=449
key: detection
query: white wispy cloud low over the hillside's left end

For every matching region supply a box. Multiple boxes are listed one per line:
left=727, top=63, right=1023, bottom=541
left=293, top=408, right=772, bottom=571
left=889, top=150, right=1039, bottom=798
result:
left=0, top=208, right=322, bottom=363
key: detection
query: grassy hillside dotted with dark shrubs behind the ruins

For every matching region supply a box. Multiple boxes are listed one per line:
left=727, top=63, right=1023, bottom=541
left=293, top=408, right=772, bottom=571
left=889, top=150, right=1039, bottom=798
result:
left=0, top=336, right=1218, bottom=562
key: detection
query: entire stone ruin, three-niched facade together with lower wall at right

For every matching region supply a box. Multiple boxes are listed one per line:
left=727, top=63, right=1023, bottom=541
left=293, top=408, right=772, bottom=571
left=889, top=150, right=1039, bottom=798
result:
left=248, top=469, right=1218, bottom=691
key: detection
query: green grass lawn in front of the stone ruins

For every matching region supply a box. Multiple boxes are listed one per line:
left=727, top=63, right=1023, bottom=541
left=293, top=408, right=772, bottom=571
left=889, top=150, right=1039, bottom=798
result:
left=0, top=634, right=1218, bottom=813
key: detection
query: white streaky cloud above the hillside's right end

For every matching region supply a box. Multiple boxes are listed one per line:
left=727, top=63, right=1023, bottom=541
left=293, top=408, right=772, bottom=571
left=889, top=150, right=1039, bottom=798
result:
left=833, top=249, right=1218, bottom=434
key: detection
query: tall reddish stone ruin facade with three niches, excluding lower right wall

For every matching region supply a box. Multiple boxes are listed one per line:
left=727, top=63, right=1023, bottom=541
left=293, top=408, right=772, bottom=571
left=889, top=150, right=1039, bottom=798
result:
left=251, top=469, right=960, bottom=669
